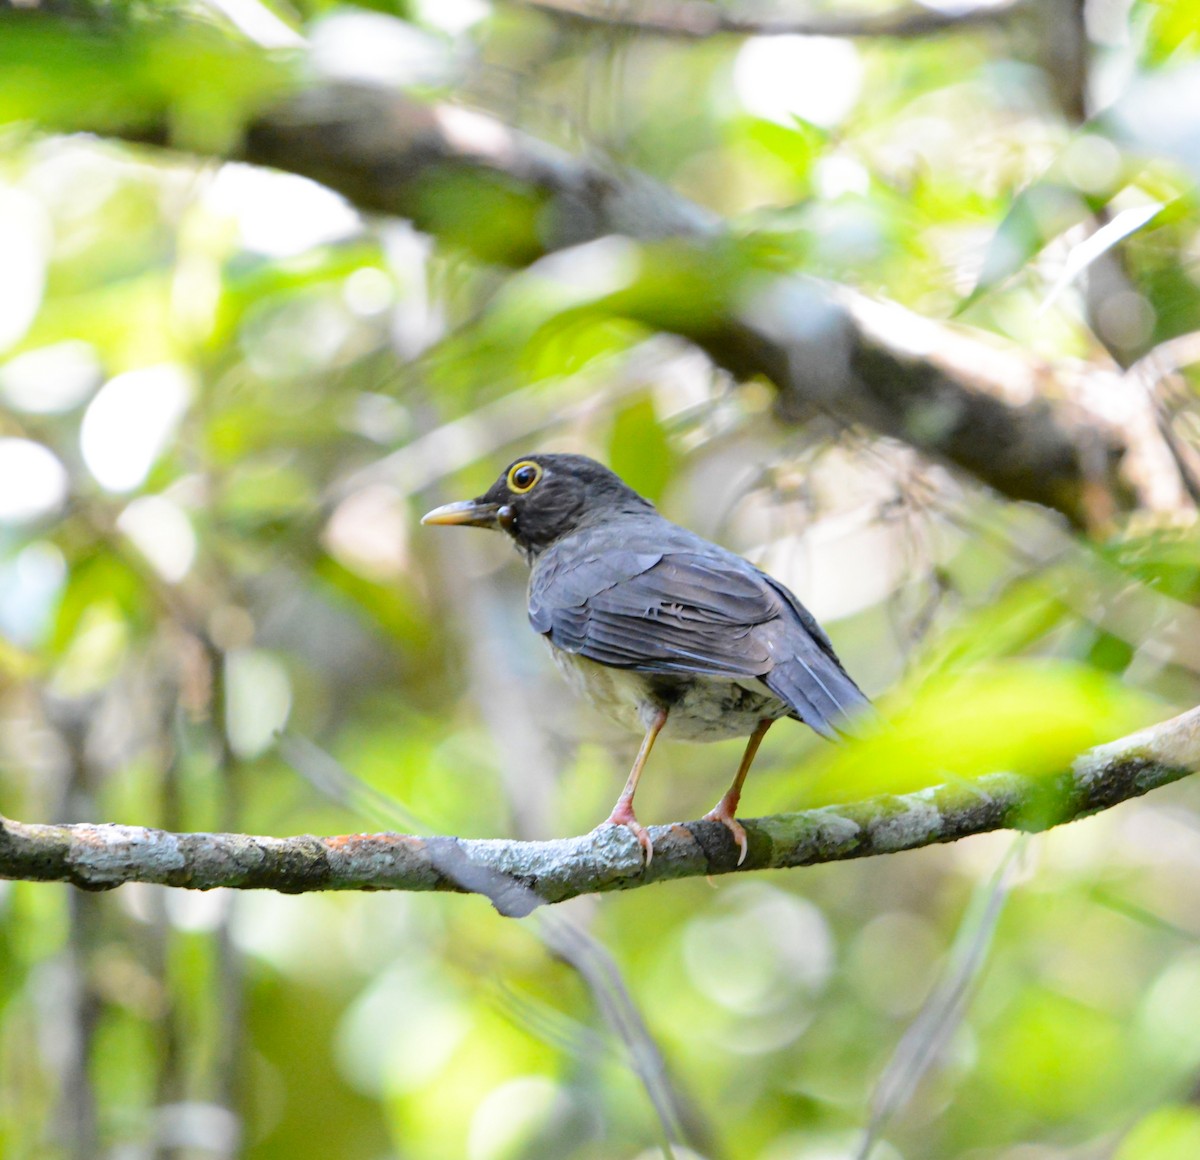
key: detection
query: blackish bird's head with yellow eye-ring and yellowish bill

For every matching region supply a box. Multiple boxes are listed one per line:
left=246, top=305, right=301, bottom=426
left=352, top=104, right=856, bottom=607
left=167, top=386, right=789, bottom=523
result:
left=421, top=455, right=653, bottom=559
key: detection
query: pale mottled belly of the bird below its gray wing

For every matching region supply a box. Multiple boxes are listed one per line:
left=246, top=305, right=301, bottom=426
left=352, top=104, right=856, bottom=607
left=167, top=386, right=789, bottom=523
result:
left=550, top=645, right=790, bottom=741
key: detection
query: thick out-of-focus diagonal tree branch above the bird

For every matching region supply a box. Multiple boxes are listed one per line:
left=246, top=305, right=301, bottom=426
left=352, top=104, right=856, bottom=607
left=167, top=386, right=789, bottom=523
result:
left=7, top=10, right=1187, bottom=528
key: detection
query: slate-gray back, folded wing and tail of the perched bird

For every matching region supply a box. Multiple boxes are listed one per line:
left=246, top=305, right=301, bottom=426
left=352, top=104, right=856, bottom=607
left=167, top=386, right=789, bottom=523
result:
left=529, top=548, right=866, bottom=737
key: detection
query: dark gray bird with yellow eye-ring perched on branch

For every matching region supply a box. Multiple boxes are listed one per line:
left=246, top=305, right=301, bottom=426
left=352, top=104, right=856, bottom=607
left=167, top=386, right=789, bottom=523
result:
left=421, top=453, right=869, bottom=866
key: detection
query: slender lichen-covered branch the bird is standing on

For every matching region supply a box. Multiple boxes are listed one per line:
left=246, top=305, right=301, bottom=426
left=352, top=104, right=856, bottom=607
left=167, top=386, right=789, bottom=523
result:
left=0, top=708, right=1200, bottom=915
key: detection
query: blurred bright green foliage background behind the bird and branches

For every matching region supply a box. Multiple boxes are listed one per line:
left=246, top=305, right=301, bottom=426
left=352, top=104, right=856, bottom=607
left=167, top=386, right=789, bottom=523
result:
left=0, top=0, right=1200, bottom=1160
